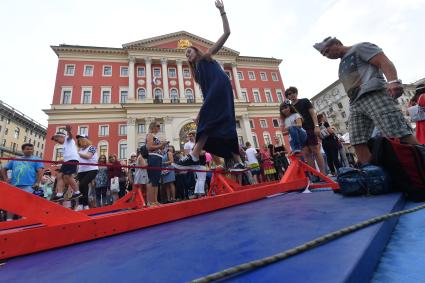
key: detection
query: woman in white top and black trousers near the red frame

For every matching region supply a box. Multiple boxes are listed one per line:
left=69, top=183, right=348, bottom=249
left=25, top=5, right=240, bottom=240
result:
left=76, top=135, right=99, bottom=210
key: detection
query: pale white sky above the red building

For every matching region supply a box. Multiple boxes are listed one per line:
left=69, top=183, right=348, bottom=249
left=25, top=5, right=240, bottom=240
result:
left=0, top=0, right=425, bottom=125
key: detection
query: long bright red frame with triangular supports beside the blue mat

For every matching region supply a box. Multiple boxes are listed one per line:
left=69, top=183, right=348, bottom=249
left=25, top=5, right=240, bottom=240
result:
left=0, top=157, right=338, bottom=259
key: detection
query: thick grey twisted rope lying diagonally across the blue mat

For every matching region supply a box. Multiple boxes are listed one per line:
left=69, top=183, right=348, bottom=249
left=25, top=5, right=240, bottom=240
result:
left=191, top=204, right=425, bottom=283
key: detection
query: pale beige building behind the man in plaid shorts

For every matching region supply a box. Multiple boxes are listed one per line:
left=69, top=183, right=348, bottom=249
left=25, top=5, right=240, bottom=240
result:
left=311, top=78, right=425, bottom=135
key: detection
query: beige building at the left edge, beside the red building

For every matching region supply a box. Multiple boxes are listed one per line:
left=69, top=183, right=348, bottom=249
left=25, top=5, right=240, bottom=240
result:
left=0, top=100, right=47, bottom=158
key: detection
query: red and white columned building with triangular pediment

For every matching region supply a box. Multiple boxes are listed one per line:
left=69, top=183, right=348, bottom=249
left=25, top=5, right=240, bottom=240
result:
left=44, top=31, right=287, bottom=160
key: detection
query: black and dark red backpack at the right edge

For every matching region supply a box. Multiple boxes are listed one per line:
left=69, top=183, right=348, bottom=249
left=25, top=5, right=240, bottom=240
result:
left=369, top=137, right=425, bottom=201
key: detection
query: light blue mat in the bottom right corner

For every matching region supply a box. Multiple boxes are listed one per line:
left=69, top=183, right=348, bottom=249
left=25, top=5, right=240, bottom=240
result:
left=371, top=203, right=425, bottom=283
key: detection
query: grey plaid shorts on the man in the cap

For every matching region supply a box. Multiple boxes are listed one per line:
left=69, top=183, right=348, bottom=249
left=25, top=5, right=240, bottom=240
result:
left=349, top=89, right=413, bottom=145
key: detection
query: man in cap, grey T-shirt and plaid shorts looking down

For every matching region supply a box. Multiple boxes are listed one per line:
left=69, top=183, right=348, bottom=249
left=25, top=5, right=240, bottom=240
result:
left=314, top=37, right=417, bottom=164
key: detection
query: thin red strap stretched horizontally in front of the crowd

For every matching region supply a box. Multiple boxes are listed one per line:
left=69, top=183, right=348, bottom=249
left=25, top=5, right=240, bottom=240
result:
left=0, top=157, right=250, bottom=175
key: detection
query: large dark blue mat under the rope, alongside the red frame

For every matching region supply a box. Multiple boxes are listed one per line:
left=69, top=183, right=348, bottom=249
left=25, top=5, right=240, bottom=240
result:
left=0, top=192, right=402, bottom=283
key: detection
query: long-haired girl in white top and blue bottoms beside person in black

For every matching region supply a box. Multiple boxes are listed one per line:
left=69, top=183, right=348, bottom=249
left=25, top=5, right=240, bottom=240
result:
left=279, top=101, right=307, bottom=153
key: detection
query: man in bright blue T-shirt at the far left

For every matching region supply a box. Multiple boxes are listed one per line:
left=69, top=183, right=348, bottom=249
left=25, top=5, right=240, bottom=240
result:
left=1, top=143, right=44, bottom=193
